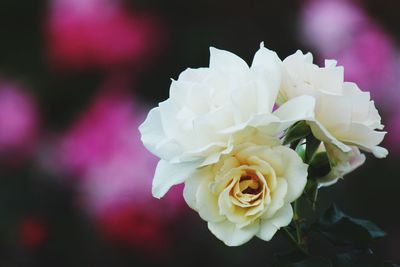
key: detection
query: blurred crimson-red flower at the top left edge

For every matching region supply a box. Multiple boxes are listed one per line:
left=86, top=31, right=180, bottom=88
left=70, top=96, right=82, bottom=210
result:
left=46, top=0, right=162, bottom=70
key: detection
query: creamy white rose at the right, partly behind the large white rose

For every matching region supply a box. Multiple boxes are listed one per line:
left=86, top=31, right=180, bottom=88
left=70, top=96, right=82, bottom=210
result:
left=278, top=51, right=388, bottom=158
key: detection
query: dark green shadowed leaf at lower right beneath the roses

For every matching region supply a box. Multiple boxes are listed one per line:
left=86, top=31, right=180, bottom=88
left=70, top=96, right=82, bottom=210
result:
left=317, top=204, right=386, bottom=247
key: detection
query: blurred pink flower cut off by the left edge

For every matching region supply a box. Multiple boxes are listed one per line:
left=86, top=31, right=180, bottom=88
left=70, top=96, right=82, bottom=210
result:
left=0, top=80, right=39, bottom=163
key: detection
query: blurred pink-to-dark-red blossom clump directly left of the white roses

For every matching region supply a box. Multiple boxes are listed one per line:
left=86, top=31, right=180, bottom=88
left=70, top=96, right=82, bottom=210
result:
left=59, top=89, right=185, bottom=249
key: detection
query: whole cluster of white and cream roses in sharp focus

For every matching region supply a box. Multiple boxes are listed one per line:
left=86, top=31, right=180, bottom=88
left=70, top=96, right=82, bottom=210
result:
left=139, top=44, right=388, bottom=246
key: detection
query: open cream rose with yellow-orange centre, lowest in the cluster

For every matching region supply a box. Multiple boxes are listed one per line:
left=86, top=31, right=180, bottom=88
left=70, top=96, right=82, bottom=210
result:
left=184, top=143, right=307, bottom=246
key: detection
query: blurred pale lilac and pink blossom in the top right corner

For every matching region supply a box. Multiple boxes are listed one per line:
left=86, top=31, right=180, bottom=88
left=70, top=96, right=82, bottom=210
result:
left=300, top=0, right=398, bottom=100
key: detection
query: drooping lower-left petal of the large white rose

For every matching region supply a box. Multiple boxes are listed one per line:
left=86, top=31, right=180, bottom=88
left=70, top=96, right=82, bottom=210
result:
left=152, top=160, right=199, bottom=198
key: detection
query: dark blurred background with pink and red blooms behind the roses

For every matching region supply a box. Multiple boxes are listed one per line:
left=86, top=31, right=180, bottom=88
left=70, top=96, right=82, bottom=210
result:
left=0, top=0, right=400, bottom=267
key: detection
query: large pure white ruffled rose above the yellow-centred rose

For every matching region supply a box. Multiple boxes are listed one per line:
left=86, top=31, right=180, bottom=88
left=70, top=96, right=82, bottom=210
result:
left=139, top=44, right=315, bottom=197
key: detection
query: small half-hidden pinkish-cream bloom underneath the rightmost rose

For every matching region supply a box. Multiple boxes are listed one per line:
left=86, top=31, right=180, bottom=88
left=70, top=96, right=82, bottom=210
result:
left=318, top=144, right=365, bottom=187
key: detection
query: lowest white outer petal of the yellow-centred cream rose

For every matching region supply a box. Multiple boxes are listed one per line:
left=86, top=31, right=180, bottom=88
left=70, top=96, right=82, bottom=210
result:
left=208, top=220, right=259, bottom=247
